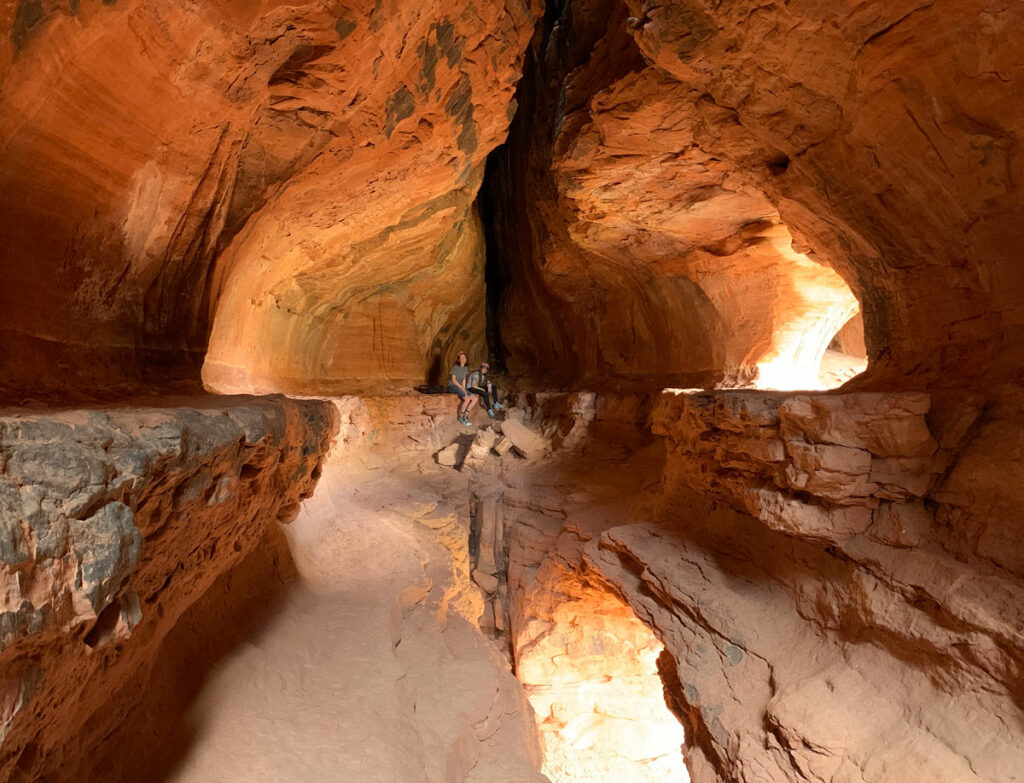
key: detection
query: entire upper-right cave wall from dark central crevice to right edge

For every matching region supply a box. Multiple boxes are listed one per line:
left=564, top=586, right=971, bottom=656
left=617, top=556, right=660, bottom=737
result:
left=485, top=0, right=1024, bottom=388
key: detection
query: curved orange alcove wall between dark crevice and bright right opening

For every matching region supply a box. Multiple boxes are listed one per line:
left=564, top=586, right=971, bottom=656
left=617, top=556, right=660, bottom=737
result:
left=483, top=0, right=858, bottom=391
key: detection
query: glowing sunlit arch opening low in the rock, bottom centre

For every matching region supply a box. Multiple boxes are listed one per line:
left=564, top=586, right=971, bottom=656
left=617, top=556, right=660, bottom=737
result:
left=513, top=575, right=689, bottom=783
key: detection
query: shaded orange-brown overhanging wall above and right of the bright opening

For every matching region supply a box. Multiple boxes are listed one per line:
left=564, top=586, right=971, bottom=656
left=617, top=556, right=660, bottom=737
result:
left=614, top=0, right=1024, bottom=384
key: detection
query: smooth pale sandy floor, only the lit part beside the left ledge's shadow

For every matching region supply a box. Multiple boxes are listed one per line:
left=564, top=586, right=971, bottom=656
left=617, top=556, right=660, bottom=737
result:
left=163, top=440, right=547, bottom=783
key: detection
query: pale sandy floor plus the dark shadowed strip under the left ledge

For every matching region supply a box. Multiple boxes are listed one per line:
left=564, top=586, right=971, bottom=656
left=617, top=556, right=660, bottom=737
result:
left=86, top=397, right=544, bottom=783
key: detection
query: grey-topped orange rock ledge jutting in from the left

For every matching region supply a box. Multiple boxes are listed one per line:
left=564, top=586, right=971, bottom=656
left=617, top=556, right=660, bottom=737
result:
left=0, top=397, right=335, bottom=780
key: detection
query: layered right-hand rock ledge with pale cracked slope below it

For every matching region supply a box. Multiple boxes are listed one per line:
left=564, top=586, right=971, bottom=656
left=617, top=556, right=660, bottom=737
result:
left=586, top=392, right=1024, bottom=783
